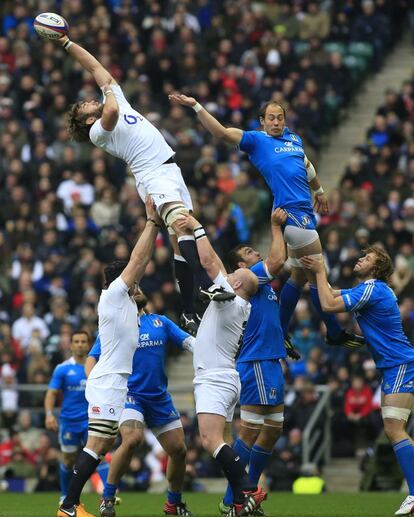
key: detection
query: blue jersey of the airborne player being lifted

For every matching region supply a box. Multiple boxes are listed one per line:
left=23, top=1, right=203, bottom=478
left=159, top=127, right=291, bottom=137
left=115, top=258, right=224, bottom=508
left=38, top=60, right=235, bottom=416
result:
left=240, top=127, right=313, bottom=213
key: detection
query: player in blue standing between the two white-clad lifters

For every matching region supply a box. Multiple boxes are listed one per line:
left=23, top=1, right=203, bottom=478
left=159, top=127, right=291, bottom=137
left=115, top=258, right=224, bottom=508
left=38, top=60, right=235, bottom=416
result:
left=86, top=289, right=194, bottom=517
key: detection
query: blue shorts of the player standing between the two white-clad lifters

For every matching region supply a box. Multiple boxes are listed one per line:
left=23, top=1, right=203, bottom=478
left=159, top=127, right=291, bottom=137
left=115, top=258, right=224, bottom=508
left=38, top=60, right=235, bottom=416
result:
left=125, top=391, right=180, bottom=429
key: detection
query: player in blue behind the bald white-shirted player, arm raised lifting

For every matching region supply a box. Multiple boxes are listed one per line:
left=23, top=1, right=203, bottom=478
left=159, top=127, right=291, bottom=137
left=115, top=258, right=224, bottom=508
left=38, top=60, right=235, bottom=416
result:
left=219, top=209, right=297, bottom=515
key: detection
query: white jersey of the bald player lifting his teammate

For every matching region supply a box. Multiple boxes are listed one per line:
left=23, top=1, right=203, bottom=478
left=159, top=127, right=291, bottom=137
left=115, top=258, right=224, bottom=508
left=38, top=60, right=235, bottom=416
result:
left=193, top=273, right=250, bottom=375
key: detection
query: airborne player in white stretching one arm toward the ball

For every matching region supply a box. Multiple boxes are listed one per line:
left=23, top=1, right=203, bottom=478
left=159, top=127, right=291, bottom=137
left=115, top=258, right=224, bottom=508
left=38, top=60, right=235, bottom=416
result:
left=47, top=36, right=234, bottom=333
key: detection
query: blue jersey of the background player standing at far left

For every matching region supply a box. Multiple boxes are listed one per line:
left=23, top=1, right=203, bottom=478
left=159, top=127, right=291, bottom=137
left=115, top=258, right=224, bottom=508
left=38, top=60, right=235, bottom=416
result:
left=49, top=357, right=88, bottom=421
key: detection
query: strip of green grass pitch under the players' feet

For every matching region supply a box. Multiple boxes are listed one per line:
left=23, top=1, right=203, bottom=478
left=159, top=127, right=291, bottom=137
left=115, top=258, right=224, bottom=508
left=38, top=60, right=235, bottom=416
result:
left=0, top=492, right=405, bottom=517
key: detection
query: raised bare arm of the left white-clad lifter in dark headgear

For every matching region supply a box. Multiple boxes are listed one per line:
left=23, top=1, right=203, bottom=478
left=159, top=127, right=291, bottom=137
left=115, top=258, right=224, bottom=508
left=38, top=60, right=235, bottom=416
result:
left=121, top=196, right=161, bottom=288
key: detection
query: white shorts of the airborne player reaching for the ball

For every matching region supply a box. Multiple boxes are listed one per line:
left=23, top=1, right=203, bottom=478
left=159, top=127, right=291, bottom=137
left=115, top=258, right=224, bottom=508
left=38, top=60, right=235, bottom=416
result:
left=136, top=163, right=193, bottom=212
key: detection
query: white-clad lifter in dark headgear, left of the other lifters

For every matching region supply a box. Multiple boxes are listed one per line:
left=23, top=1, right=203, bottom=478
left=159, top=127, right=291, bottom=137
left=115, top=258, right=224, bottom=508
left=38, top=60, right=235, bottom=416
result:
left=57, top=196, right=161, bottom=517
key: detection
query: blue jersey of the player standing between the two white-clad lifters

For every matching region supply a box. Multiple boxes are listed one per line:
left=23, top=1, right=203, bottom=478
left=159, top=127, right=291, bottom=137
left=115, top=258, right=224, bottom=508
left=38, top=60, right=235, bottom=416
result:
left=89, top=314, right=190, bottom=398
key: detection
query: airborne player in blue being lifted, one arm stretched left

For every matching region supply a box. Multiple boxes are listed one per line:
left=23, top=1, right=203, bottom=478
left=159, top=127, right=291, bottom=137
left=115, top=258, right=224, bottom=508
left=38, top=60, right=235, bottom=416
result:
left=169, top=94, right=364, bottom=347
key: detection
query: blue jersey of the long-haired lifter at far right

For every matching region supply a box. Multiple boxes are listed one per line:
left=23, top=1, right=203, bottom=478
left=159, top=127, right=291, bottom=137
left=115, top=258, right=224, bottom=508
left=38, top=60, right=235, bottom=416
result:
left=341, top=280, right=414, bottom=368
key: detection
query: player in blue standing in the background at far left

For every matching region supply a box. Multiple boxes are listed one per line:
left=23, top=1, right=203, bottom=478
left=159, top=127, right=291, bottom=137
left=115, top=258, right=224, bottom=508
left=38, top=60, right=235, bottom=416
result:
left=44, top=330, right=108, bottom=508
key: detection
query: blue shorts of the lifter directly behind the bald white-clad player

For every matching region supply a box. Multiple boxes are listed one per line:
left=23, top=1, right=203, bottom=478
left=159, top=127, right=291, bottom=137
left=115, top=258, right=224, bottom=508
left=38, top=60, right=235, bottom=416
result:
left=236, top=359, right=285, bottom=406
